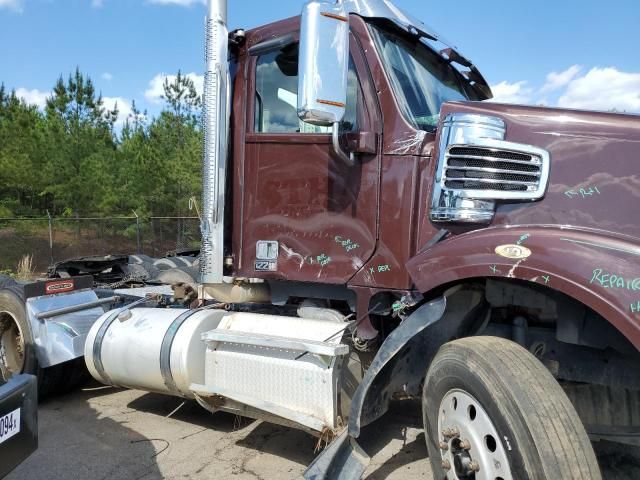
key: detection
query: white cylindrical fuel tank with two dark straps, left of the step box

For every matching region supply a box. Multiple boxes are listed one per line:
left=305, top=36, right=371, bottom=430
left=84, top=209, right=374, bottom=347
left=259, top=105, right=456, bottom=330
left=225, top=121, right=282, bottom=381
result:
left=85, top=308, right=226, bottom=398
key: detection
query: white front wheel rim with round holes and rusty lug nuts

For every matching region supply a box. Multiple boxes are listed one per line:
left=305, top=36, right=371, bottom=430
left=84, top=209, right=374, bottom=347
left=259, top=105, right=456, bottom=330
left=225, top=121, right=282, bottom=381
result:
left=438, top=389, right=513, bottom=480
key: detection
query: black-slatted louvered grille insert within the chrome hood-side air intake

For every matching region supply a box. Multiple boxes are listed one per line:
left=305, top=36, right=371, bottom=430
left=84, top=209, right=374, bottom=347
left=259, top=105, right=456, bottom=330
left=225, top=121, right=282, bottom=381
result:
left=442, top=145, right=542, bottom=192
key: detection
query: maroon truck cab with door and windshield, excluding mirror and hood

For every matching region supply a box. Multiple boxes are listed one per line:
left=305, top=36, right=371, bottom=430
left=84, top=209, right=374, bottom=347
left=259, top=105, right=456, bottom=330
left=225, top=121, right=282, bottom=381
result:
left=229, top=15, right=484, bottom=291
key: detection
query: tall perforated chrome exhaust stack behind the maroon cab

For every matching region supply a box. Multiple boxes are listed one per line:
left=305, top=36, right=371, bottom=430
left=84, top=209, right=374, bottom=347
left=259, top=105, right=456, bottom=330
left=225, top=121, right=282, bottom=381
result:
left=200, top=0, right=229, bottom=284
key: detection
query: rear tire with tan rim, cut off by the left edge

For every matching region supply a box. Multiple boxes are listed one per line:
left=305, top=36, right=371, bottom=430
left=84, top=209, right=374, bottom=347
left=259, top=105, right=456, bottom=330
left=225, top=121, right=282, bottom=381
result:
left=0, top=283, right=89, bottom=398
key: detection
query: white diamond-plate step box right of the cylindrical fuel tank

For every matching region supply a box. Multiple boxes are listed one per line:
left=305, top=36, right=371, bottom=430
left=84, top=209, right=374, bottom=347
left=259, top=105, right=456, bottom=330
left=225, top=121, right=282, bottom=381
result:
left=203, top=313, right=345, bottom=428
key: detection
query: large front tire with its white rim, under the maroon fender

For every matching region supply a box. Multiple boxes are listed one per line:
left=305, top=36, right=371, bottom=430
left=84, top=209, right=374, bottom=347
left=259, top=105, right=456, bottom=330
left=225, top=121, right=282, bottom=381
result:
left=422, top=337, right=602, bottom=480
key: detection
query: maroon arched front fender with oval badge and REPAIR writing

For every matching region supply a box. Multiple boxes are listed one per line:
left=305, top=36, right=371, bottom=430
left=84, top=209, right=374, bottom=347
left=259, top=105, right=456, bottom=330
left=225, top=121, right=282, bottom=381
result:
left=407, top=225, right=640, bottom=349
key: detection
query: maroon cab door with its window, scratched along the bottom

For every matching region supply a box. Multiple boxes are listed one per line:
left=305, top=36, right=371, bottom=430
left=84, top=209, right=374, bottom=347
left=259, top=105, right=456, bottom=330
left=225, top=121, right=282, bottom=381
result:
left=236, top=27, right=381, bottom=284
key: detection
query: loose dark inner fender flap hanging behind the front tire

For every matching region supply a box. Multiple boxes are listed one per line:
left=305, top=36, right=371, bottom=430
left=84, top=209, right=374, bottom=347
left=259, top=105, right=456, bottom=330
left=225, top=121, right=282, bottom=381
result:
left=304, top=288, right=483, bottom=480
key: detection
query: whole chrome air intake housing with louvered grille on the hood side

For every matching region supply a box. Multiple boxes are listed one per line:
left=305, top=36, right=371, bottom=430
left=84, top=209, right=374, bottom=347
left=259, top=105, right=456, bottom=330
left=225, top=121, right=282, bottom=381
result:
left=429, top=112, right=551, bottom=224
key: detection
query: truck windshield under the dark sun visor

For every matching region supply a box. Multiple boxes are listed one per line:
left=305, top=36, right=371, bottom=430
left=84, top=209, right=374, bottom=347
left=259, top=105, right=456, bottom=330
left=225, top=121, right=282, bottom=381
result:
left=371, top=24, right=476, bottom=131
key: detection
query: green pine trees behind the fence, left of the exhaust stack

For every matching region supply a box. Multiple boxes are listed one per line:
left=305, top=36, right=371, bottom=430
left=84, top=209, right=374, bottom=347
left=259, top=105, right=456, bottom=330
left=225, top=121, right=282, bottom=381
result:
left=0, top=70, right=202, bottom=217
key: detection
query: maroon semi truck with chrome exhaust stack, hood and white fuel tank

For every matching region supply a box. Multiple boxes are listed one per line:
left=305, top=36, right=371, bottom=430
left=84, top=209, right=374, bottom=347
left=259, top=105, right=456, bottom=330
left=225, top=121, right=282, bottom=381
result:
left=1, top=0, right=640, bottom=480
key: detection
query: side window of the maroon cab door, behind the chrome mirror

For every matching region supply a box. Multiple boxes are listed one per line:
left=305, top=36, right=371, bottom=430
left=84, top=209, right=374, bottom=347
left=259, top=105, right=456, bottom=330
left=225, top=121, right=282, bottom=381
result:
left=254, top=44, right=360, bottom=134
